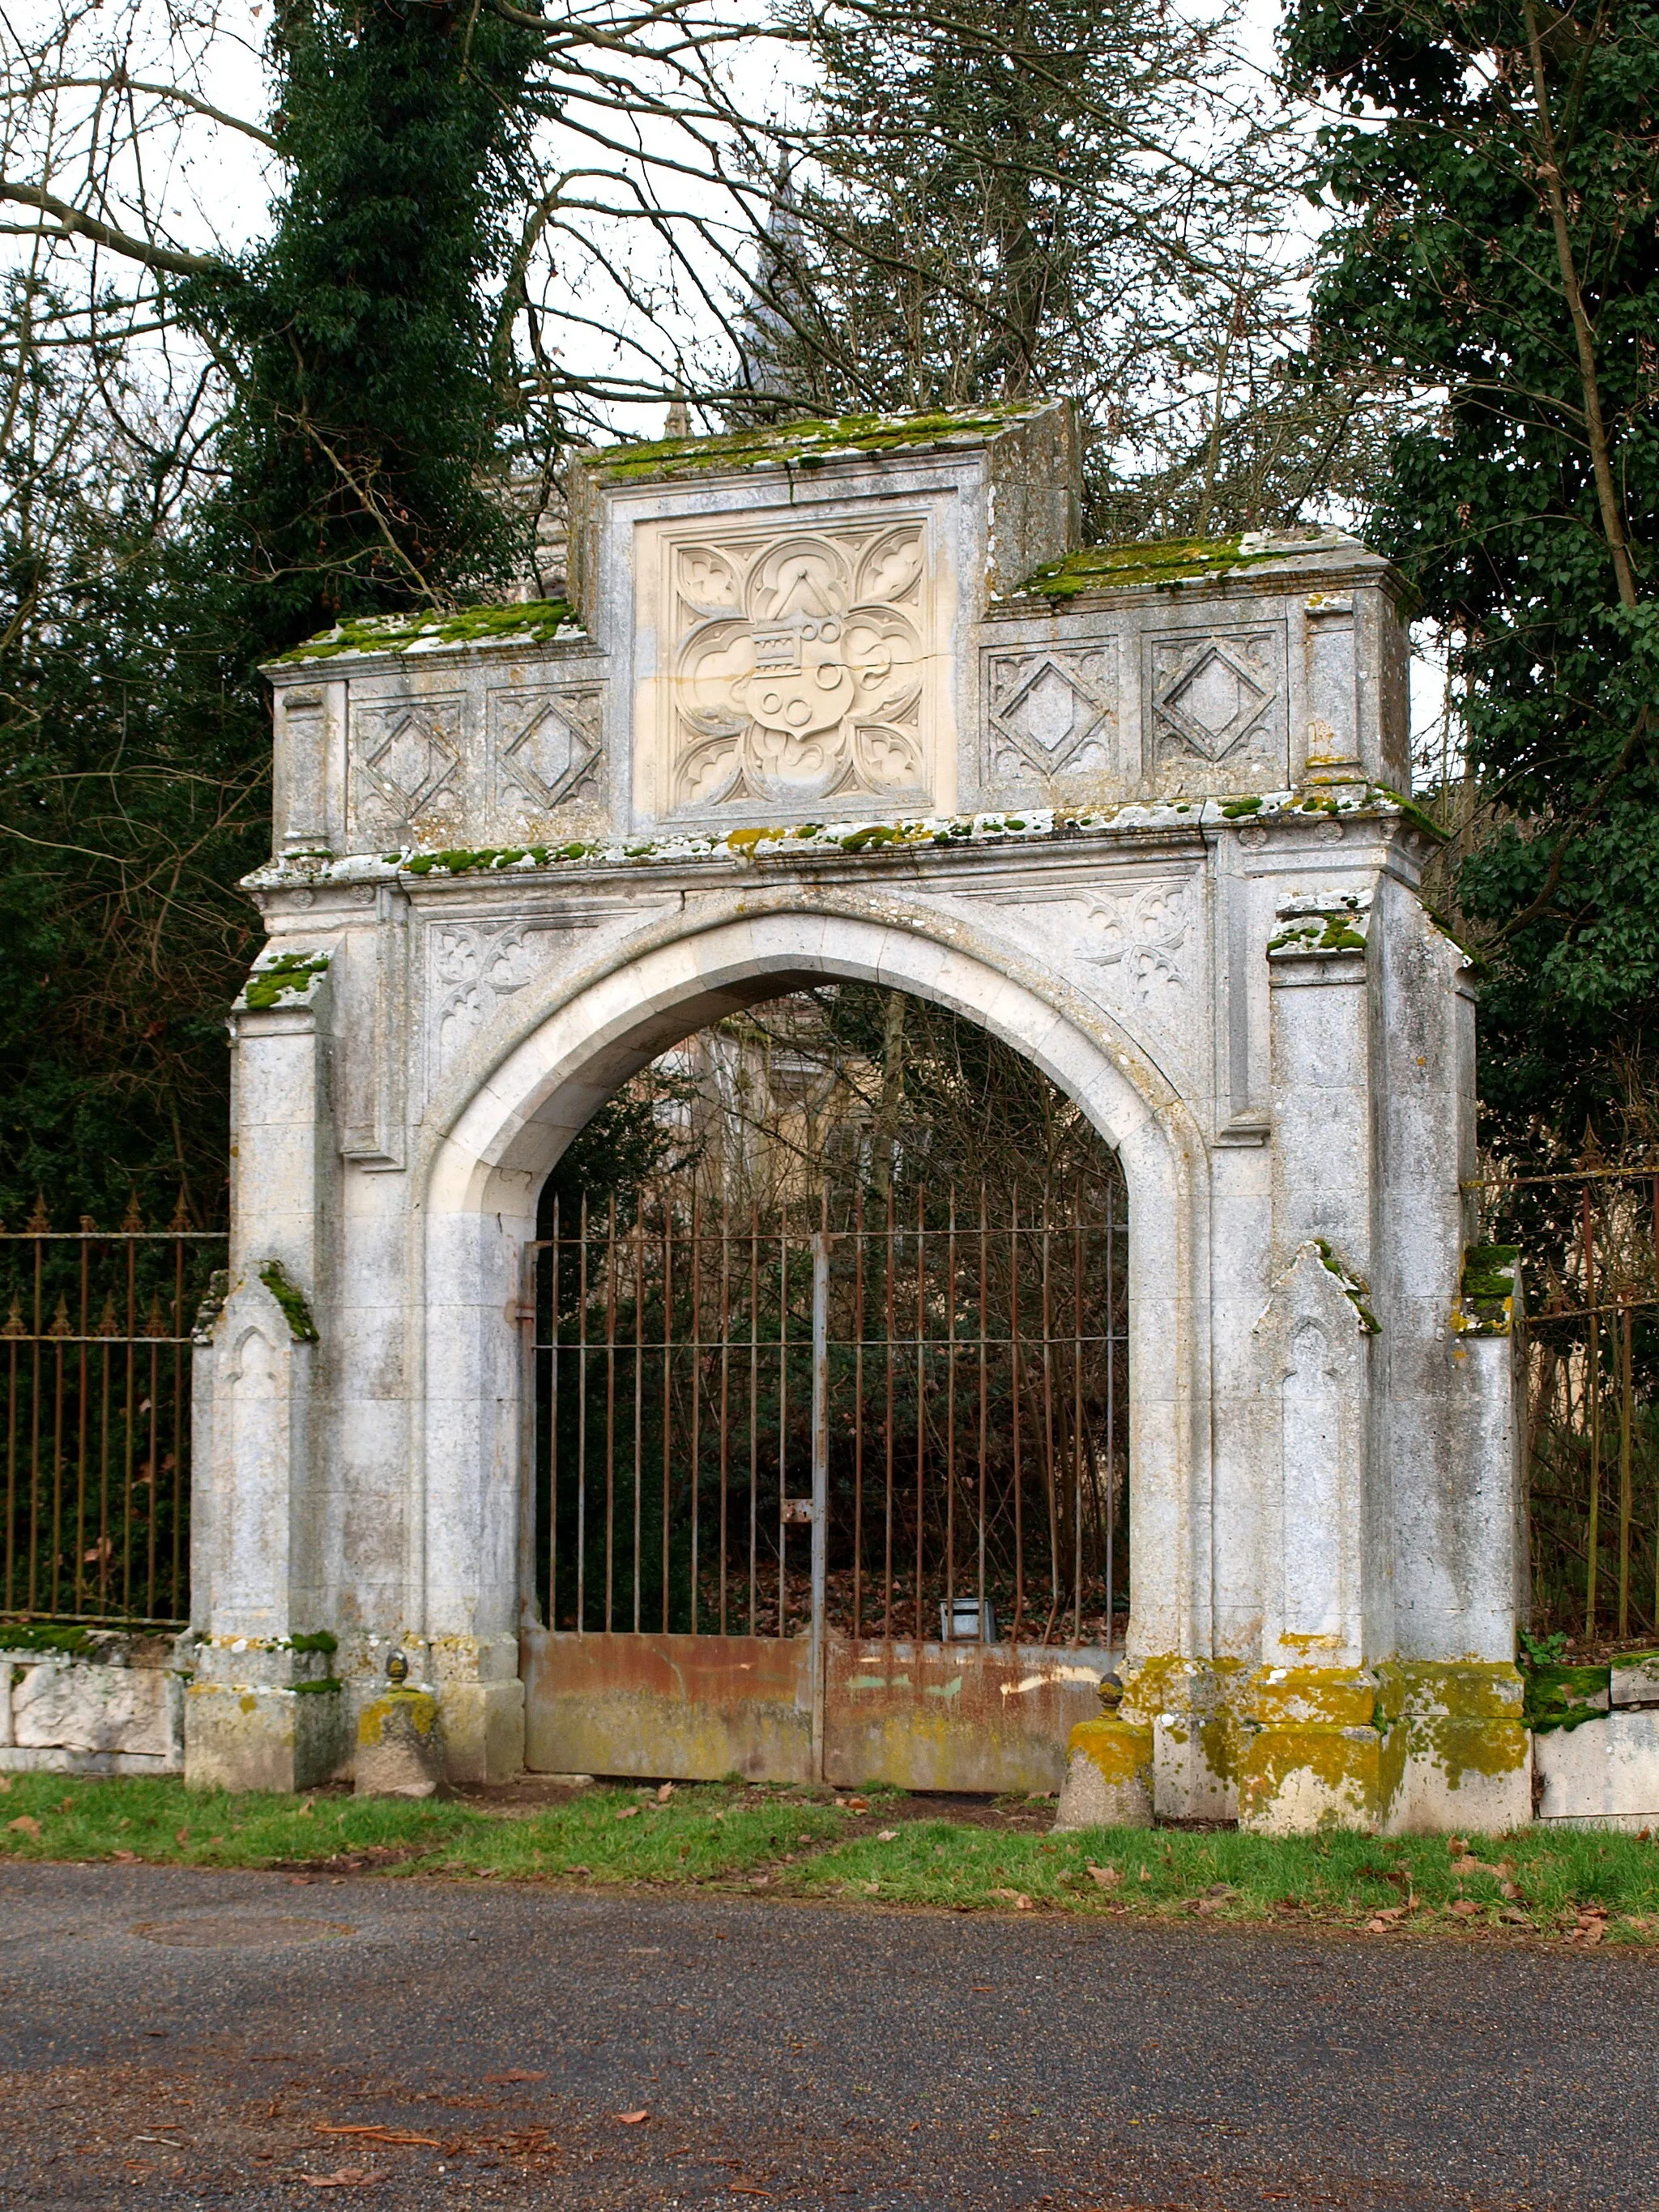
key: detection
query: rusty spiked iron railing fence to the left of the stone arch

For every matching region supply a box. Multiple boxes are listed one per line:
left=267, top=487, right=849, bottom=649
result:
left=0, top=1205, right=226, bottom=1628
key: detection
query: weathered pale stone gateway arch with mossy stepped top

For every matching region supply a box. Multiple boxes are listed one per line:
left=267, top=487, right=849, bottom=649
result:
left=186, top=405, right=1531, bottom=1830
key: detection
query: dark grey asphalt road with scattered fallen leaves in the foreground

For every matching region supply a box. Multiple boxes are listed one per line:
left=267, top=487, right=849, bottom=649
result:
left=0, top=1863, right=1659, bottom=2212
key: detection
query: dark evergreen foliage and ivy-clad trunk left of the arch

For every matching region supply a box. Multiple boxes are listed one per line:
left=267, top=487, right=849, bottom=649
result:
left=0, top=0, right=533, bottom=1221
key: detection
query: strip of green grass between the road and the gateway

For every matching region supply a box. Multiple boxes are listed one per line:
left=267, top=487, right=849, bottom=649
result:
left=0, top=1774, right=1659, bottom=1946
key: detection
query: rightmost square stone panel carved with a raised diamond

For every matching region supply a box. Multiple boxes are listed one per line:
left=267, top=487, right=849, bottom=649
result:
left=1145, top=624, right=1290, bottom=792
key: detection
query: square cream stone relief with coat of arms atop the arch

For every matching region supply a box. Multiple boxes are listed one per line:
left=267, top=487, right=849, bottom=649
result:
left=668, top=522, right=927, bottom=808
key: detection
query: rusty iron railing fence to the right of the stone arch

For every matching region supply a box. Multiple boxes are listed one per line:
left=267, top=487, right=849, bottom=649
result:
left=1478, top=1166, right=1659, bottom=1641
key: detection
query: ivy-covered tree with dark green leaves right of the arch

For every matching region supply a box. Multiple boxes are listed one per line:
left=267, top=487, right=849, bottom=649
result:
left=1287, top=0, right=1659, bottom=1153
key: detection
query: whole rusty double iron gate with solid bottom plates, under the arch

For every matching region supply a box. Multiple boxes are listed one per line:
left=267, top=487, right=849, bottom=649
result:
left=524, top=1186, right=1128, bottom=1789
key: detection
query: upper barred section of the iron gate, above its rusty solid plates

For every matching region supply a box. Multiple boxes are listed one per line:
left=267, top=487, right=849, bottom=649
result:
left=524, top=1183, right=1128, bottom=1643
